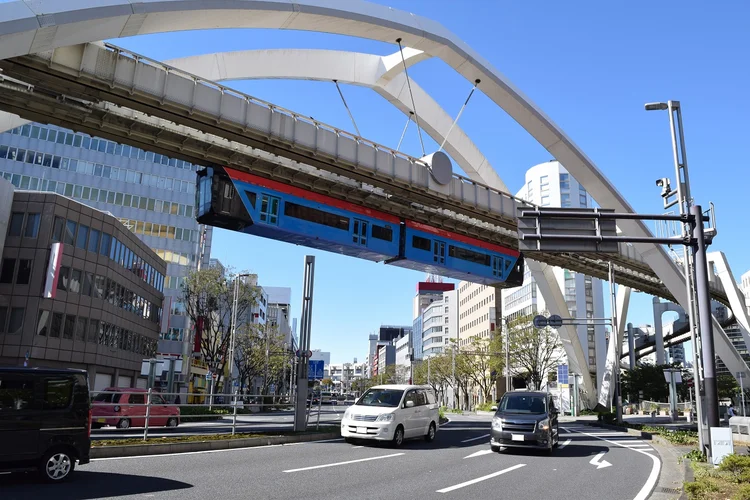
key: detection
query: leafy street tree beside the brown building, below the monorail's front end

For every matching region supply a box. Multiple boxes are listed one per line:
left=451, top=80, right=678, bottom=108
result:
left=181, top=267, right=259, bottom=387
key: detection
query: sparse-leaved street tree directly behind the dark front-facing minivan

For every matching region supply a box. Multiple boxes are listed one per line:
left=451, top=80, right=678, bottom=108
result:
left=506, top=315, right=563, bottom=390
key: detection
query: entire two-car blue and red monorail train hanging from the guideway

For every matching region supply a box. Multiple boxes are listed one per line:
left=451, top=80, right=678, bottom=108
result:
left=196, top=167, right=524, bottom=288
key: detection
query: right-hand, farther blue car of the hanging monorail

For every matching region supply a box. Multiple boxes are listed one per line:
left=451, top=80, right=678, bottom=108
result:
left=391, top=220, right=524, bottom=287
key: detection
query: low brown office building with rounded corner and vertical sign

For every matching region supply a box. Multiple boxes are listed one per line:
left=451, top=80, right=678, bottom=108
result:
left=0, top=184, right=166, bottom=390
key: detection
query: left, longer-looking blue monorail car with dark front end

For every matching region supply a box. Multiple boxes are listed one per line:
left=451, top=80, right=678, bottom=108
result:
left=196, top=168, right=401, bottom=262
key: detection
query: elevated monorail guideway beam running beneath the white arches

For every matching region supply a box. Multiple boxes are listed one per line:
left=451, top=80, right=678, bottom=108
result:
left=0, top=43, right=728, bottom=303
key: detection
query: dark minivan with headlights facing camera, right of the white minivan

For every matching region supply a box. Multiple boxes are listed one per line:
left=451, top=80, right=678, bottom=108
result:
left=490, top=391, right=559, bottom=453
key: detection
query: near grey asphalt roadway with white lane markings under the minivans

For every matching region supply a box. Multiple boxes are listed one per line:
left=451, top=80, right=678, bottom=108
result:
left=0, top=416, right=660, bottom=500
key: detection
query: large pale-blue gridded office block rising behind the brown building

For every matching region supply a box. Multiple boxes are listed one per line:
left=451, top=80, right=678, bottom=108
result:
left=0, top=123, right=213, bottom=376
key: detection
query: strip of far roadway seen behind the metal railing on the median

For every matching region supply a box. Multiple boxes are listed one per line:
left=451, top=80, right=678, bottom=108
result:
left=91, top=405, right=348, bottom=439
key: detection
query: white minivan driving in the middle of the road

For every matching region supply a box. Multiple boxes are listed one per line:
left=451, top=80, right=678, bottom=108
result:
left=341, top=385, right=440, bottom=446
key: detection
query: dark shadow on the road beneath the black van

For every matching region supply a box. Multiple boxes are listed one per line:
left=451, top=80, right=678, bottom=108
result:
left=0, top=470, right=193, bottom=500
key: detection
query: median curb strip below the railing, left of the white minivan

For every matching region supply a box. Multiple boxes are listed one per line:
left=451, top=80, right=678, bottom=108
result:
left=91, top=432, right=341, bottom=459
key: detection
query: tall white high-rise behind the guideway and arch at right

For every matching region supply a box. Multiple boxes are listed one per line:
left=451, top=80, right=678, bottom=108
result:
left=502, top=161, right=607, bottom=386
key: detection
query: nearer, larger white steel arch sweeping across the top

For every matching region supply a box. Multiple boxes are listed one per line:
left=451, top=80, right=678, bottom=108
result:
left=0, top=0, right=749, bottom=382
